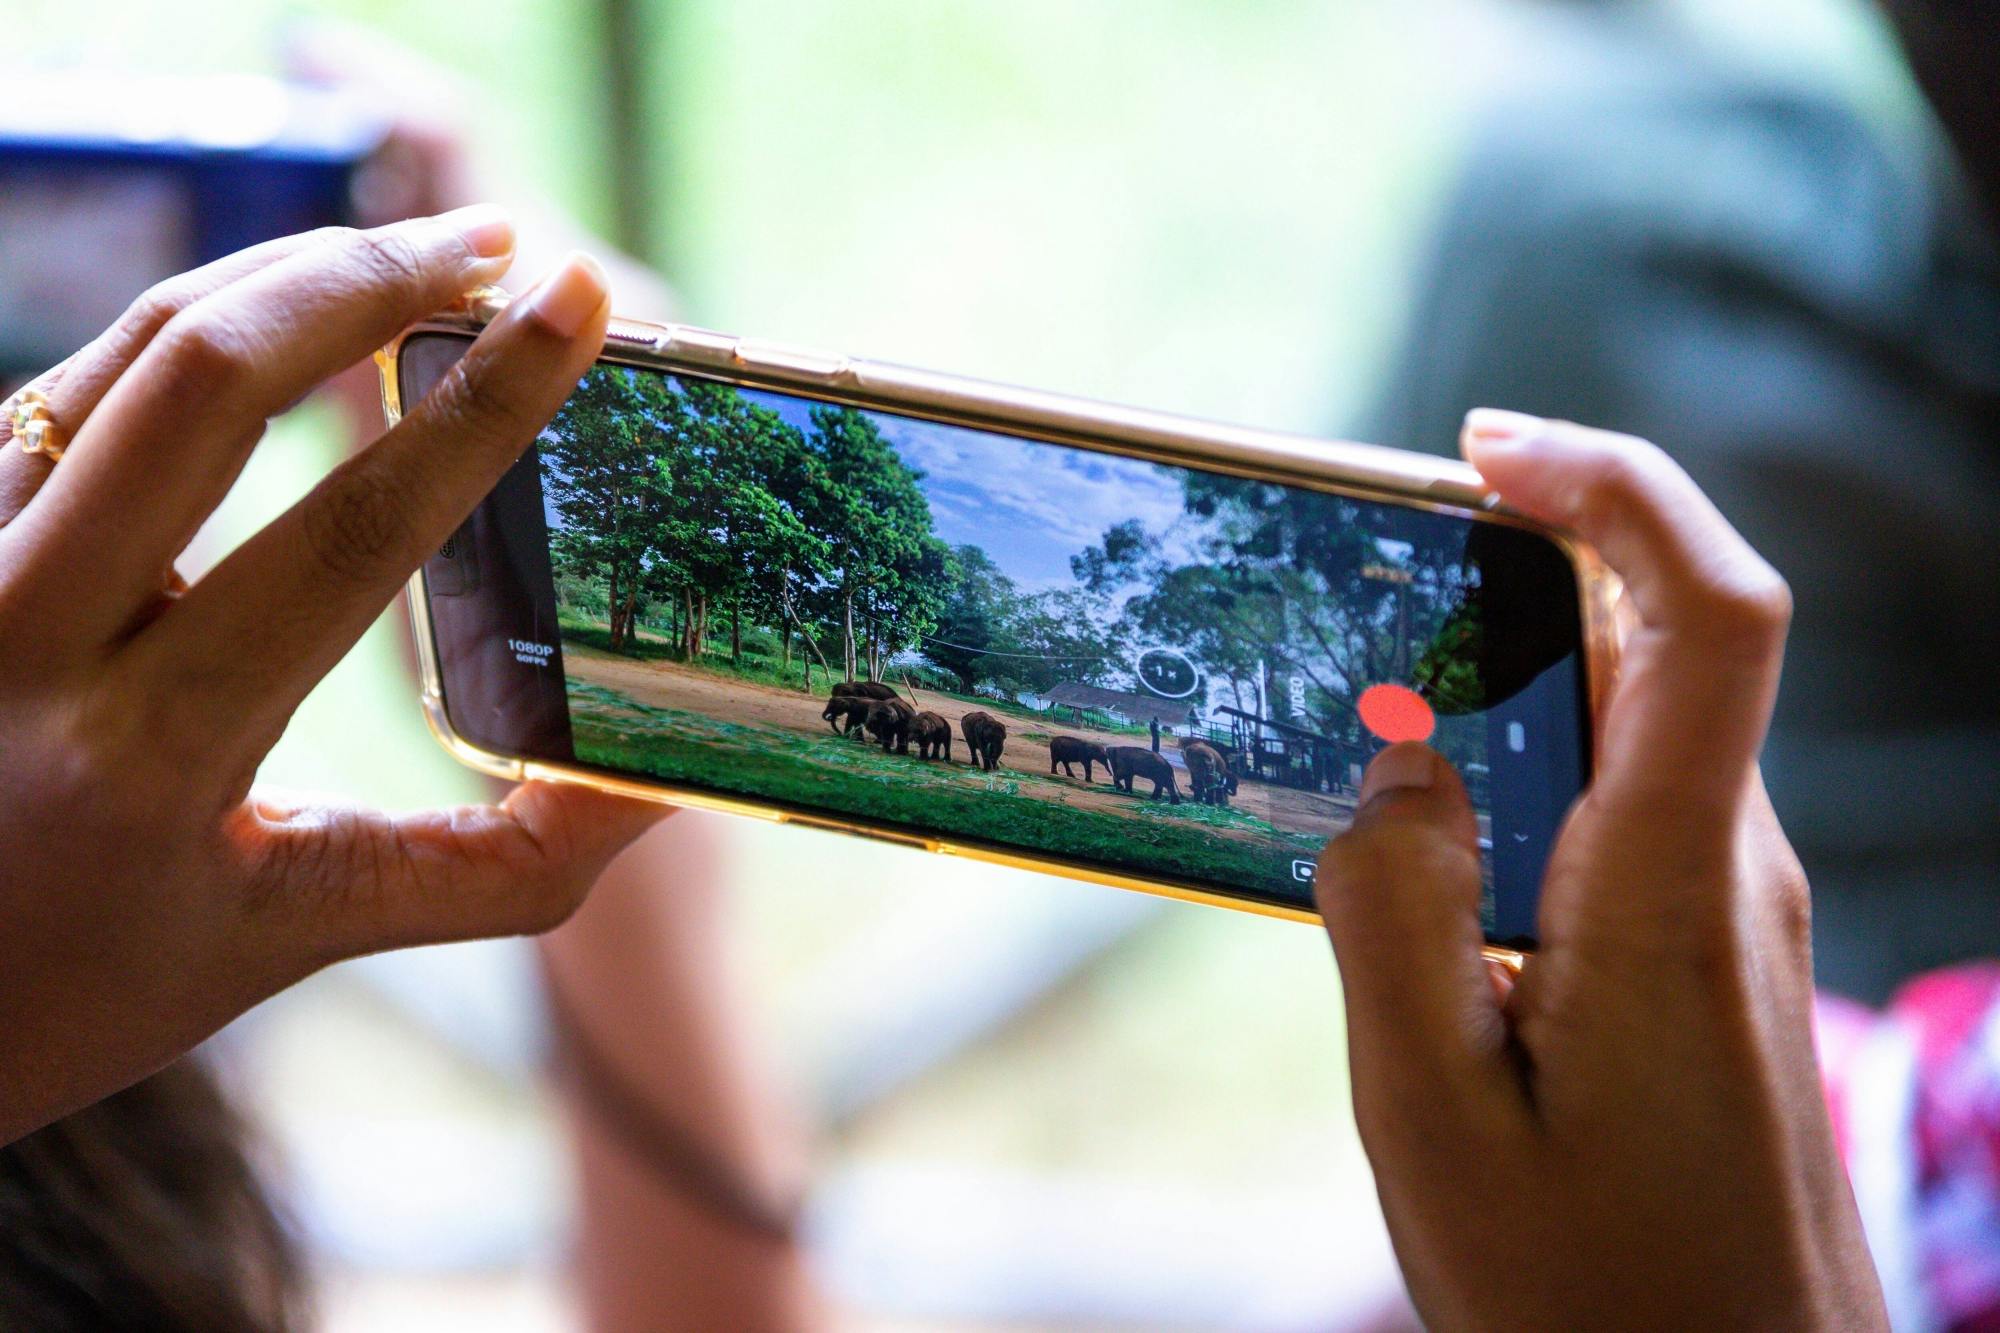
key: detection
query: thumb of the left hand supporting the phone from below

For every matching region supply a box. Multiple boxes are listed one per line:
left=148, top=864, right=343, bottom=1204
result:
left=244, top=783, right=672, bottom=963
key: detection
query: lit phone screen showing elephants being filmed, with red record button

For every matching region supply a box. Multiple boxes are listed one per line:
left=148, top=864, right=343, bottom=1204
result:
left=410, top=342, right=1582, bottom=943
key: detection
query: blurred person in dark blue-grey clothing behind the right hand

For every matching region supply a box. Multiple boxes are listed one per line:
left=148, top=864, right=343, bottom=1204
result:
left=1364, top=2, right=2000, bottom=999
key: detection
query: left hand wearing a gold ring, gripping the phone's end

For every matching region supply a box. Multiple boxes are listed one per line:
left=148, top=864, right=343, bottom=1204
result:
left=0, top=208, right=660, bottom=1143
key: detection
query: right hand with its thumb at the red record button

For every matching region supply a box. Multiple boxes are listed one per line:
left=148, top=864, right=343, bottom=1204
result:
left=1316, top=410, right=1886, bottom=1329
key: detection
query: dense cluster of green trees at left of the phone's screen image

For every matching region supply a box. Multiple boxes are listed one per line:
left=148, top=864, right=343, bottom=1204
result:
left=542, top=368, right=952, bottom=679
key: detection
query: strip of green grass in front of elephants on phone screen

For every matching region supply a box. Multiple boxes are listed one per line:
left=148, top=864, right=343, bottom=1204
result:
left=570, top=681, right=1320, bottom=895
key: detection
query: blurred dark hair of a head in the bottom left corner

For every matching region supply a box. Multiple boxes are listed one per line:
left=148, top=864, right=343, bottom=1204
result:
left=0, top=1057, right=304, bottom=1333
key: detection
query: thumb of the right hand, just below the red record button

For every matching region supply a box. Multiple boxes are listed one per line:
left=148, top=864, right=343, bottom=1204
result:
left=1314, top=743, right=1506, bottom=1129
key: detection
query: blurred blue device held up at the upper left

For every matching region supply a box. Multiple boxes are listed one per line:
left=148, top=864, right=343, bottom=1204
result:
left=0, top=70, right=388, bottom=374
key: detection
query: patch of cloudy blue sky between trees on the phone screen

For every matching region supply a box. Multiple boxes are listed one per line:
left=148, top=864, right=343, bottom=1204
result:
left=744, top=378, right=1184, bottom=590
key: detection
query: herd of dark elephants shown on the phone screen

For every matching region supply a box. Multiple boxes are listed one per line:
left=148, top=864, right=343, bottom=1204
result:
left=820, top=681, right=1236, bottom=807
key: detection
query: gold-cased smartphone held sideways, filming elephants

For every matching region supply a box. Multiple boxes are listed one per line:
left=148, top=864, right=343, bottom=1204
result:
left=378, top=292, right=1618, bottom=957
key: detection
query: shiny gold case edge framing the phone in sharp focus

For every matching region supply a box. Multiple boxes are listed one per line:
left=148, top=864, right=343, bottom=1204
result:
left=376, top=288, right=1620, bottom=965
